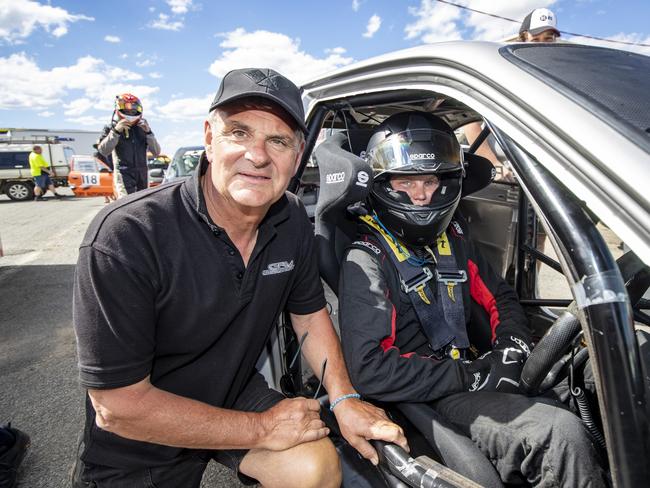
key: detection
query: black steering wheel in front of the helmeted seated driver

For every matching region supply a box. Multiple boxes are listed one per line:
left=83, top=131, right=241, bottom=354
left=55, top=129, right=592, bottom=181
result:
left=519, top=251, right=650, bottom=395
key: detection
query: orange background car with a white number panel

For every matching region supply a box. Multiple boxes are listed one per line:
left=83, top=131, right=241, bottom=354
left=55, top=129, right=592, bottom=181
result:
left=68, top=155, right=114, bottom=197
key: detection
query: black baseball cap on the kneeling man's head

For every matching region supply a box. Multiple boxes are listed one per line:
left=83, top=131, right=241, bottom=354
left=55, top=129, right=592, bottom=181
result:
left=210, top=68, right=307, bottom=133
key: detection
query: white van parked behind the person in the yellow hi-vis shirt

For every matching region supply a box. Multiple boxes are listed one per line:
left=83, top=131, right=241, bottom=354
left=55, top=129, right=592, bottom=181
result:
left=0, top=137, right=74, bottom=200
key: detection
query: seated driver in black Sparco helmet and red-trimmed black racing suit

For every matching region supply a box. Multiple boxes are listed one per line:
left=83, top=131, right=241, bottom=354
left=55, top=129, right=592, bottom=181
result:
left=339, top=112, right=606, bottom=486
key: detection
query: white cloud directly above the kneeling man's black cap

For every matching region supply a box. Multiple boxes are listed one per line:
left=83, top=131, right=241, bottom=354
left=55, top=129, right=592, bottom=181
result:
left=210, top=27, right=353, bottom=83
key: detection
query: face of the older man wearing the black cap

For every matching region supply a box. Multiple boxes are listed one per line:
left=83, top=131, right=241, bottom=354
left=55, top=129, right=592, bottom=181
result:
left=205, top=107, right=304, bottom=209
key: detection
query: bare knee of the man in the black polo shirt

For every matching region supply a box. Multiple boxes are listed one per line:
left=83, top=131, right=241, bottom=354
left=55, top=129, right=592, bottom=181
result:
left=240, top=438, right=341, bottom=488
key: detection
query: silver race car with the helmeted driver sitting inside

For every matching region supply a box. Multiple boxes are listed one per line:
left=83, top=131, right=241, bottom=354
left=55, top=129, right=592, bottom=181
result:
left=244, top=42, right=650, bottom=488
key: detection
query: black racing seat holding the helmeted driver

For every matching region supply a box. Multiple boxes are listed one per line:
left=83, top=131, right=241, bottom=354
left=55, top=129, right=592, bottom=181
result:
left=313, top=132, right=503, bottom=487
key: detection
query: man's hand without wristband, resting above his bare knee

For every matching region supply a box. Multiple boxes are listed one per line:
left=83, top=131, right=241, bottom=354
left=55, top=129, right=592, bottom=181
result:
left=259, top=398, right=329, bottom=451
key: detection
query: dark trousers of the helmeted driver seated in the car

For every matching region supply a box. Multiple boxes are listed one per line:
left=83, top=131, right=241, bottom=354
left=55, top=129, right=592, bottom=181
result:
left=433, top=392, right=609, bottom=488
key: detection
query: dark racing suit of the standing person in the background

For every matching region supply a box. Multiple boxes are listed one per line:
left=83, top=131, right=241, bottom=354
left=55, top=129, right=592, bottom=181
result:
left=97, top=125, right=160, bottom=193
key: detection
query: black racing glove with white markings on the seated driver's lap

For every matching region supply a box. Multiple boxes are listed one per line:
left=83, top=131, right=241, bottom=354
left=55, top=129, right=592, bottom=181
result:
left=465, top=336, right=530, bottom=393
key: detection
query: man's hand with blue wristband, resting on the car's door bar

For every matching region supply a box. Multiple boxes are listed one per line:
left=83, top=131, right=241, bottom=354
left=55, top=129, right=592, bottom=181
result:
left=334, top=398, right=409, bottom=466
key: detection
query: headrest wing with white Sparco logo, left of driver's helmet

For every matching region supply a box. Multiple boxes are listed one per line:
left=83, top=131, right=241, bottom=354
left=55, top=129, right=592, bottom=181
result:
left=314, top=132, right=372, bottom=221
